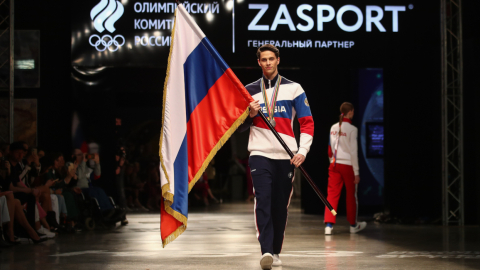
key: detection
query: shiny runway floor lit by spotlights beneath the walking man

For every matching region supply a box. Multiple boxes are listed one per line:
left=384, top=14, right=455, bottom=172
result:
left=0, top=203, right=480, bottom=270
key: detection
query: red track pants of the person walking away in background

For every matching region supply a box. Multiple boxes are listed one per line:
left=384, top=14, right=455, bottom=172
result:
left=325, top=163, right=357, bottom=225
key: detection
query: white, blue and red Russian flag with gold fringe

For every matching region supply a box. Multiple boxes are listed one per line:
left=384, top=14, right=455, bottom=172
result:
left=160, top=5, right=253, bottom=247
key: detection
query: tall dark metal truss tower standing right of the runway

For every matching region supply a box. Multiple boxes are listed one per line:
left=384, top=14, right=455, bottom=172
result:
left=440, top=0, right=465, bottom=226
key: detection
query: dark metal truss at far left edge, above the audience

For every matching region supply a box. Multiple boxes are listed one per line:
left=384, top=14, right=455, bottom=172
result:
left=0, top=0, right=14, bottom=143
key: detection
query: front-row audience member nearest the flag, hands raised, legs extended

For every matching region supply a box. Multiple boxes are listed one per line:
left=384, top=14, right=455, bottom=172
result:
left=73, top=149, right=124, bottom=219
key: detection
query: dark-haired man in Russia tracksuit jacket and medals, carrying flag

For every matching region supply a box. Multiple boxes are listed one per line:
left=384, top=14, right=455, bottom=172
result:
left=239, top=44, right=313, bottom=269
